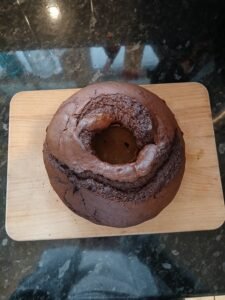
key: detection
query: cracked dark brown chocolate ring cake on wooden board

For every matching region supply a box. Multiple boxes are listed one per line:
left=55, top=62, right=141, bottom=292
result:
left=43, top=82, right=185, bottom=227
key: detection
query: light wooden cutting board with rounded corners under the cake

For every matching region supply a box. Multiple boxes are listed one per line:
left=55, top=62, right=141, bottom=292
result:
left=6, top=83, right=225, bottom=240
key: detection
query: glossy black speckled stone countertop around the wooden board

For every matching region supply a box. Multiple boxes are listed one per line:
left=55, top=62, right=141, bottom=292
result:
left=0, top=0, right=225, bottom=299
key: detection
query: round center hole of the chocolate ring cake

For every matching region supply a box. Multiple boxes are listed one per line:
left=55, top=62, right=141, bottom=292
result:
left=92, top=123, right=139, bottom=164
